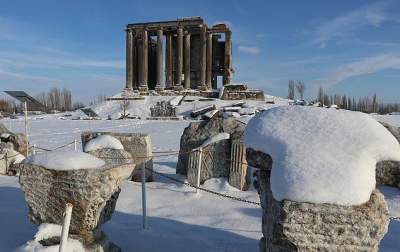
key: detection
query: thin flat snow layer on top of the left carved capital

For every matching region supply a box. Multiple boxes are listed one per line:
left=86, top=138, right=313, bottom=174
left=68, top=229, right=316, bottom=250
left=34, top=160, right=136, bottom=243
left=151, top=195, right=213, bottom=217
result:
left=24, top=151, right=105, bottom=171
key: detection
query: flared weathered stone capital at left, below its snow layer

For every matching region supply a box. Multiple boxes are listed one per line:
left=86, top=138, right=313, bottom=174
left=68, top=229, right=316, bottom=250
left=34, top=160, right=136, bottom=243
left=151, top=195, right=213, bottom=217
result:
left=19, top=161, right=133, bottom=243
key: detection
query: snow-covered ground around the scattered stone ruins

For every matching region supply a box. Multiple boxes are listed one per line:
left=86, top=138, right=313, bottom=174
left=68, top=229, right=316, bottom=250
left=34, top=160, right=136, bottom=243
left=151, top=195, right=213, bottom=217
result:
left=0, top=99, right=400, bottom=252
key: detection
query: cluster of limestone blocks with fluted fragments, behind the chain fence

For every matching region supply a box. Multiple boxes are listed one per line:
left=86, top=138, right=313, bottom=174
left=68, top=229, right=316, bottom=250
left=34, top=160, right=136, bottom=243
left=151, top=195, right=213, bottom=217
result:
left=176, top=112, right=249, bottom=190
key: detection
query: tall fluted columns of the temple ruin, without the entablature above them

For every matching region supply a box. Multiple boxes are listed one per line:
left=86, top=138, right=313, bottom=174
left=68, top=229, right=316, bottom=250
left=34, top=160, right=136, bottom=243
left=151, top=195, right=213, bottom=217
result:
left=126, top=25, right=232, bottom=89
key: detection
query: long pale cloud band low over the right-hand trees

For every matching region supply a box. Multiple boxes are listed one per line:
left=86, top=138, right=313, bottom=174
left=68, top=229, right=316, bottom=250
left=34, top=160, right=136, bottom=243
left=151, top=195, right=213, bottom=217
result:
left=323, top=54, right=400, bottom=86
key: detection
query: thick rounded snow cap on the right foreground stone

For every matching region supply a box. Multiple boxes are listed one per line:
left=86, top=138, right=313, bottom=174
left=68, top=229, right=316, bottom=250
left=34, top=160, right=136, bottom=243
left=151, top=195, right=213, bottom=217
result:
left=244, top=106, right=400, bottom=205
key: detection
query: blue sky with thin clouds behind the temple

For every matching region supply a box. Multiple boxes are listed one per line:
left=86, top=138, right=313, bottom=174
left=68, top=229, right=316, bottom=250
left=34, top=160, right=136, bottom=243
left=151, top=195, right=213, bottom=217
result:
left=0, top=0, right=400, bottom=102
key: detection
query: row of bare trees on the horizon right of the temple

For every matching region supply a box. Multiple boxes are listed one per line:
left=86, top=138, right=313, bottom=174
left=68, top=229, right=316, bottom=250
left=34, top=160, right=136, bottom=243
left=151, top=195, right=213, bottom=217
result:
left=288, top=80, right=400, bottom=114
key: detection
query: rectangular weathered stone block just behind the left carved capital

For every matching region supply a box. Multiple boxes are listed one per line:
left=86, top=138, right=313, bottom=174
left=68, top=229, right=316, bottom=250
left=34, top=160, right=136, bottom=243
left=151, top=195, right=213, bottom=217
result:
left=81, top=132, right=153, bottom=181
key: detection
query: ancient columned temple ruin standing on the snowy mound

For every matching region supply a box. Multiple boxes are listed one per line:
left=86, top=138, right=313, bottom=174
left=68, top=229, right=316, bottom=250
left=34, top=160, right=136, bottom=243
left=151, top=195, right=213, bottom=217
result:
left=126, top=17, right=233, bottom=91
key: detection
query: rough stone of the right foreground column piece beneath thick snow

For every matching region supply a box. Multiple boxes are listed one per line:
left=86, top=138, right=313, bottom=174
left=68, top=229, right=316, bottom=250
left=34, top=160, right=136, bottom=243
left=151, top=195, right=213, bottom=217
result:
left=247, top=149, right=389, bottom=252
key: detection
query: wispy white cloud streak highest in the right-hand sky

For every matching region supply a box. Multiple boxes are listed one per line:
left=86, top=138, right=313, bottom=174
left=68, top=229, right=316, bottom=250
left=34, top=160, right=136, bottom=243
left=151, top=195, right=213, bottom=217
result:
left=313, top=2, right=397, bottom=47
